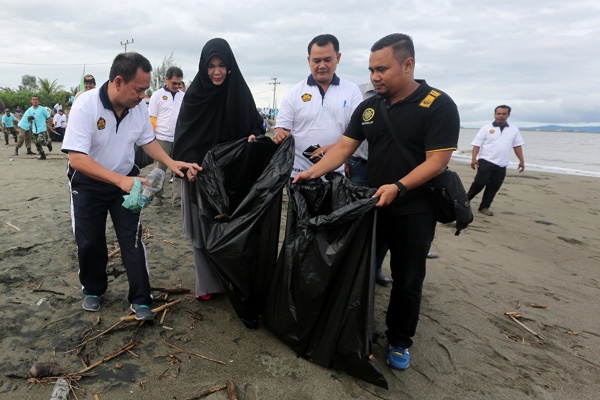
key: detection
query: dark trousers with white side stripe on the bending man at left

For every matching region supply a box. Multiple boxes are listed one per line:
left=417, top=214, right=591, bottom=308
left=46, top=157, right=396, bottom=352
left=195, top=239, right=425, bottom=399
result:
left=67, top=166, right=152, bottom=305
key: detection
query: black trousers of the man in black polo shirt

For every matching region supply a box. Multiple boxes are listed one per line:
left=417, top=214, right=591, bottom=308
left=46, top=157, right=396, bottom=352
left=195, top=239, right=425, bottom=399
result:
left=376, top=212, right=436, bottom=348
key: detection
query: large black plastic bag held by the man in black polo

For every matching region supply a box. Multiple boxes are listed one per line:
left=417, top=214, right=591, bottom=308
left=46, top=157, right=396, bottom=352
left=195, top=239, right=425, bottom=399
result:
left=263, top=173, right=387, bottom=389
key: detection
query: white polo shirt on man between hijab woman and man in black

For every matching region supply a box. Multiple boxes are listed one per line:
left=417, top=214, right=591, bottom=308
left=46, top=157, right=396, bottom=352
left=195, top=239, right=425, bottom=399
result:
left=275, top=75, right=363, bottom=177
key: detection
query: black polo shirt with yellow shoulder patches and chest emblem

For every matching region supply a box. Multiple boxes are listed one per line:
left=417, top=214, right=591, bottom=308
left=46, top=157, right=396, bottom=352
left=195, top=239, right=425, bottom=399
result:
left=344, top=80, right=460, bottom=215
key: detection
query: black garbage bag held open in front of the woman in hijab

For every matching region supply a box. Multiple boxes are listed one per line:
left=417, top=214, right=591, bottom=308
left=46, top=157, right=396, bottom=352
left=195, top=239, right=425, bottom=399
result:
left=195, top=136, right=294, bottom=328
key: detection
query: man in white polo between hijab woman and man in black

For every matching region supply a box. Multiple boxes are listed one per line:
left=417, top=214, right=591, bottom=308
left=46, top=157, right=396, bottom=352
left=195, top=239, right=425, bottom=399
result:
left=273, top=34, right=363, bottom=177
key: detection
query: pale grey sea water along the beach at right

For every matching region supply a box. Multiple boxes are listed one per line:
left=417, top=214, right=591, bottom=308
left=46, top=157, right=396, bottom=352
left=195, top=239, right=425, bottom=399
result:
left=452, top=128, right=600, bottom=177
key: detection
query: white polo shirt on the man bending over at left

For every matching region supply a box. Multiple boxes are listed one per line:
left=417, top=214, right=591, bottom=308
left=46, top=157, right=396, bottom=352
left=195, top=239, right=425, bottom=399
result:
left=61, top=82, right=156, bottom=175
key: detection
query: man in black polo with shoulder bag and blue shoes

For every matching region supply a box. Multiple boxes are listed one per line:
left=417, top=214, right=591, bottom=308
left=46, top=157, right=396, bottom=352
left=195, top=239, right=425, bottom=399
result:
left=294, top=33, right=460, bottom=370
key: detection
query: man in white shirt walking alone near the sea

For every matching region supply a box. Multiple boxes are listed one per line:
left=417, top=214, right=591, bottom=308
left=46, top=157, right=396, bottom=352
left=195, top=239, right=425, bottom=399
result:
left=467, top=105, right=525, bottom=217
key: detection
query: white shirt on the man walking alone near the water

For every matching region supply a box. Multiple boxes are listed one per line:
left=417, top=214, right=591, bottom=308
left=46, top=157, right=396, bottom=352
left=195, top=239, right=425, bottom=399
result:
left=471, top=122, right=525, bottom=167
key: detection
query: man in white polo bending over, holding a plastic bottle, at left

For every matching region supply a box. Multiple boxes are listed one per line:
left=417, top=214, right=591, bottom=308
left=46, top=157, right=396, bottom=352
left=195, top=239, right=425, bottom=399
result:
left=62, top=52, right=200, bottom=320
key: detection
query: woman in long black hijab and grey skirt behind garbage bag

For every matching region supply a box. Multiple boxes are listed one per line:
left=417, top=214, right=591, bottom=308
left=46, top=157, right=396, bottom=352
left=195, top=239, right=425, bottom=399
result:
left=173, top=38, right=264, bottom=300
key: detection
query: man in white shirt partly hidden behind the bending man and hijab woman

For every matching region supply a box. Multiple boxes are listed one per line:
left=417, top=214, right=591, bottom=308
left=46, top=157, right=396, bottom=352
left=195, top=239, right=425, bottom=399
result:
left=148, top=67, right=185, bottom=206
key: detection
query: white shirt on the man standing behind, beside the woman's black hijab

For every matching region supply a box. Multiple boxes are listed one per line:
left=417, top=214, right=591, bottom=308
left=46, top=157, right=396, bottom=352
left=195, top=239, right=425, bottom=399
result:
left=148, top=87, right=185, bottom=142
